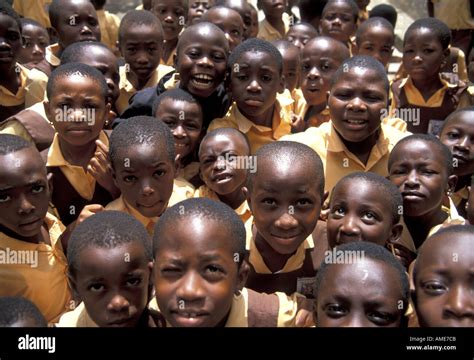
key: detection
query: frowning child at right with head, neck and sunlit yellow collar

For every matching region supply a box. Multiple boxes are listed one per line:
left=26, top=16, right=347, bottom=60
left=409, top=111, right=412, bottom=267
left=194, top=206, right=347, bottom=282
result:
left=388, top=134, right=464, bottom=252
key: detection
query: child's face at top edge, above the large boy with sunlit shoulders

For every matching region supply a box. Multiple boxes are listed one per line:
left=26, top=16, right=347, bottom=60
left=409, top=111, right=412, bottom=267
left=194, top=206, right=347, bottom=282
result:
left=319, top=2, right=356, bottom=43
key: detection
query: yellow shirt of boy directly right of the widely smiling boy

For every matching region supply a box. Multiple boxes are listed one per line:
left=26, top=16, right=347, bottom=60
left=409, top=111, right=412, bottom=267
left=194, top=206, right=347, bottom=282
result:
left=208, top=99, right=292, bottom=154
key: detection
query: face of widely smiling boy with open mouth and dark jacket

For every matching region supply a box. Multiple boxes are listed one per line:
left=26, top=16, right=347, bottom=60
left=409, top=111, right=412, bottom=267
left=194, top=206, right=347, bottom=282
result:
left=176, top=27, right=229, bottom=98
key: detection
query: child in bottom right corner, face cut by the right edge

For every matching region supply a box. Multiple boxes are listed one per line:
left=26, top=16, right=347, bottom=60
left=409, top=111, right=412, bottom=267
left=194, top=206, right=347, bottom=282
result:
left=412, top=225, right=474, bottom=328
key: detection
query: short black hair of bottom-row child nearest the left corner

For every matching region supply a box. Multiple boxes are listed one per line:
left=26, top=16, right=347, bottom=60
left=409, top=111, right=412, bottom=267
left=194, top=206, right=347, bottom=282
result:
left=67, top=211, right=153, bottom=276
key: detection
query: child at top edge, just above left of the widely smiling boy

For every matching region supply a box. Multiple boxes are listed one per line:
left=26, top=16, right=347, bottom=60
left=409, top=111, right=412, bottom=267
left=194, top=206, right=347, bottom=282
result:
left=151, top=0, right=188, bottom=66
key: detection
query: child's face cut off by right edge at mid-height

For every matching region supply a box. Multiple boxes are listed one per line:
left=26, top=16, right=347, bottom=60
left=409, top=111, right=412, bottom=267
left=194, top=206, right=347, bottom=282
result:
left=439, top=111, right=474, bottom=176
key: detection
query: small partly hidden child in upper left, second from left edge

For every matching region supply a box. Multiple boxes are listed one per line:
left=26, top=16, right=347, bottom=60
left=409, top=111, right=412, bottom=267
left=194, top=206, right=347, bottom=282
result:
left=19, top=19, right=49, bottom=70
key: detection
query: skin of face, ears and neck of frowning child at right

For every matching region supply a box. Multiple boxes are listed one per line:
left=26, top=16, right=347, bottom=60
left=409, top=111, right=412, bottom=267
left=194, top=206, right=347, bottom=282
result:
left=389, top=140, right=457, bottom=248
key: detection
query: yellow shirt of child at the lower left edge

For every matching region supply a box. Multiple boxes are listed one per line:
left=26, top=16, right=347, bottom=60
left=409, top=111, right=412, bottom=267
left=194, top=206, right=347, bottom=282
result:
left=0, top=214, right=70, bottom=322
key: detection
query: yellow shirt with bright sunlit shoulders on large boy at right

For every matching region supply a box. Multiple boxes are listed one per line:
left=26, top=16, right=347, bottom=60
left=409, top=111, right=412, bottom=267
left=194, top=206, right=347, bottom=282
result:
left=281, top=122, right=410, bottom=192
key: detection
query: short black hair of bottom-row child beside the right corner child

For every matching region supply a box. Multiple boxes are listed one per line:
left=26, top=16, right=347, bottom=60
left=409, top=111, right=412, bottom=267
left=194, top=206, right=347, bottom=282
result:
left=315, top=241, right=410, bottom=309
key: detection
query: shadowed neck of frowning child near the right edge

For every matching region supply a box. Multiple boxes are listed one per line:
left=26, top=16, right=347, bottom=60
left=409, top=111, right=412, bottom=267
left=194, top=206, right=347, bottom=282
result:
left=403, top=206, right=448, bottom=249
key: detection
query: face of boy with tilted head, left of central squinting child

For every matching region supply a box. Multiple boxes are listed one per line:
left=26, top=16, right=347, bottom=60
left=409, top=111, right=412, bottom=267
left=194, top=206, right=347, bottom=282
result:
left=113, top=143, right=176, bottom=218
